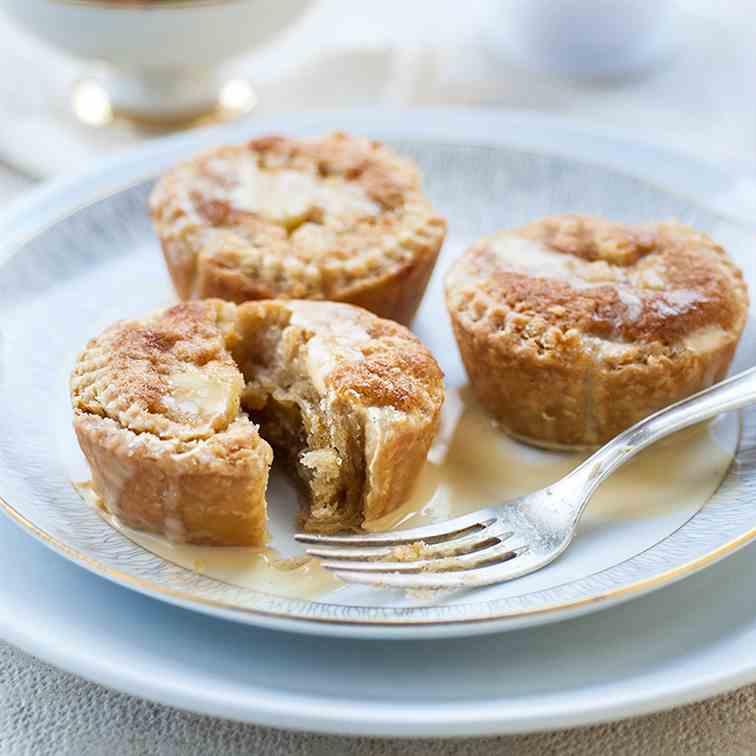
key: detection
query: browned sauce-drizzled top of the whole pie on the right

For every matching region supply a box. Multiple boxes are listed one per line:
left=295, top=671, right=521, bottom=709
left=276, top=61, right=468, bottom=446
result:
left=446, top=215, right=748, bottom=361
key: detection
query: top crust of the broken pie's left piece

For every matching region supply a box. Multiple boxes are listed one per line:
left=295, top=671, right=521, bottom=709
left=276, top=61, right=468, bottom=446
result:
left=71, top=301, right=244, bottom=441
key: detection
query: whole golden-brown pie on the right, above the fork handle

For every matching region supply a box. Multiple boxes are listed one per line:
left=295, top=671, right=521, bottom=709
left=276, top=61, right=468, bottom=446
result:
left=446, top=215, right=748, bottom=447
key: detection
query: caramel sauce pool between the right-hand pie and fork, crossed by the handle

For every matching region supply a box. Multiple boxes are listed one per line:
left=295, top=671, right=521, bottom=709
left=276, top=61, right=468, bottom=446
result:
left=366, top=387, right=734, bottom=531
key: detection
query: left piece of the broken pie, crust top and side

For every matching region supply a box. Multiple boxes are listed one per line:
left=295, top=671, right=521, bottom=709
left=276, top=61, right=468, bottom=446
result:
left=71, top=301, right=273, bottom=545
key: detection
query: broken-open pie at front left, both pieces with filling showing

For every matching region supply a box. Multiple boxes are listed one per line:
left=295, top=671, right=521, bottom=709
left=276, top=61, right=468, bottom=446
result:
left=71, top=300, right=443, bottom=545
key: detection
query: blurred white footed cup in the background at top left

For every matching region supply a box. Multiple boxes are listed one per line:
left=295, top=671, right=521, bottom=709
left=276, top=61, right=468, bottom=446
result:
left=0, top=0, right=310, bottom=122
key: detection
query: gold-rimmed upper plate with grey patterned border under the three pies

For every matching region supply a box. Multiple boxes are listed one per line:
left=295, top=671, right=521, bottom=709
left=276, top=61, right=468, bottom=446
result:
left=0, top=108, right=756, bottom=638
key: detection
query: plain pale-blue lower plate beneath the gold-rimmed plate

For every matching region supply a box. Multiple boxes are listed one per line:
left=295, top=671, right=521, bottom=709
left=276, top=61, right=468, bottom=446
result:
left=0, top=478, right=756, bottom=737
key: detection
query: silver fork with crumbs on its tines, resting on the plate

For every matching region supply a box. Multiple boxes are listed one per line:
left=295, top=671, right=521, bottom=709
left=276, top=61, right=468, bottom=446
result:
left=295, top=368, right=756, bottom=589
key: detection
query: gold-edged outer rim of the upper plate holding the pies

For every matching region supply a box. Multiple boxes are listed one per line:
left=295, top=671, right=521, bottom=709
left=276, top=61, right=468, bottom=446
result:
left=0, top=108, right=756, bottom=638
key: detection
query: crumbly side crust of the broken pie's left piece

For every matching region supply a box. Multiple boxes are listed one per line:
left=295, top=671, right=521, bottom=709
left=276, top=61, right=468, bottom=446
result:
left=74, top=412, right=273, bottom=546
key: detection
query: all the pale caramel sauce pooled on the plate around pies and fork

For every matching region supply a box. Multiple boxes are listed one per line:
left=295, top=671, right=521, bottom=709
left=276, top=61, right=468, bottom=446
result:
left=77, top=388, right=736, bottom=599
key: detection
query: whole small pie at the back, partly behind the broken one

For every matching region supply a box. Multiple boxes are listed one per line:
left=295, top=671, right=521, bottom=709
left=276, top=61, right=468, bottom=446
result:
left=150, top=133, right=446, bottom=323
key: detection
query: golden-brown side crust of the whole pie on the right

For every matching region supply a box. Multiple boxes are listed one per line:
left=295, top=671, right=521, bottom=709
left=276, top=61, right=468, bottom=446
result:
left=451, top=313, right=740, bottom=449
